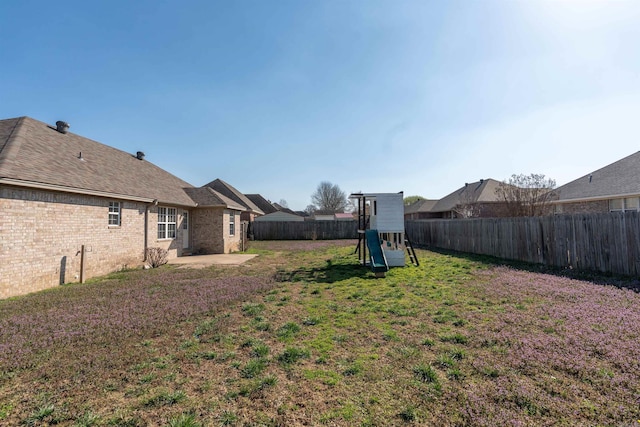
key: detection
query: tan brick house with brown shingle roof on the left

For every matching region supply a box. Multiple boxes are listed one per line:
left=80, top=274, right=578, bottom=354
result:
left=0, top=117, right=245, bottom=298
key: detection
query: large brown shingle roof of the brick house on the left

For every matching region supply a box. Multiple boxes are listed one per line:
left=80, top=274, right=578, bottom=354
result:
left=0, top=117, right=195, bottom=206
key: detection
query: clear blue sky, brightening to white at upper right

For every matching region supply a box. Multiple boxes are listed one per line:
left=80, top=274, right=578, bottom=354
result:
left=0, top=0, right=640, bottom=209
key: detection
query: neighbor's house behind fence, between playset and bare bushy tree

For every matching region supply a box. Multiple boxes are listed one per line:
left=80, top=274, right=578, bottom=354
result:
left=423, top=179, right=508, bottom=219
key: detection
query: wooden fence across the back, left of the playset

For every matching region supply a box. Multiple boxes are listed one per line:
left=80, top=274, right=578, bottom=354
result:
left=251, top=221, right=358, bottom=240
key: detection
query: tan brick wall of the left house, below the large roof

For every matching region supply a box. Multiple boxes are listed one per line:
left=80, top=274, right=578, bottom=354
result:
left=0, top=186, right=188, bottom=298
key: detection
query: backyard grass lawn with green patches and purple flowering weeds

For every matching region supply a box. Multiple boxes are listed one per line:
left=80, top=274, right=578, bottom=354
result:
left=0, top=241, right=640, bottom=427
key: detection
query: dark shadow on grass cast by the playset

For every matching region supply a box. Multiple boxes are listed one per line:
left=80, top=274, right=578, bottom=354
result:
left=275, top=260, right=376, bottom=283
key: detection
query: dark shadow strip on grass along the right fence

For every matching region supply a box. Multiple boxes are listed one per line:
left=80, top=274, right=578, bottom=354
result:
left=416, top=246, right=640, bottom=292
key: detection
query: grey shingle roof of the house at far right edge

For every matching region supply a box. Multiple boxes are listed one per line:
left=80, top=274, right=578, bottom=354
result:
left=554, top=151, right=640, bottom=203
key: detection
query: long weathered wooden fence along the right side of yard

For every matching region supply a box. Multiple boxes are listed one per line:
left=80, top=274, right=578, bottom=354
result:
left=405, top=212, right=640, bottom=276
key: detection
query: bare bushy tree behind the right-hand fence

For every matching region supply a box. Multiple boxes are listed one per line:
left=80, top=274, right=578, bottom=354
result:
left=496, top=173, right=556, bottom=216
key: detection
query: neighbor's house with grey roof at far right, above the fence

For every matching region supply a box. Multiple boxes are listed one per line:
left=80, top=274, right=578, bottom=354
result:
left=552, top=151, right=640, bottom=213
